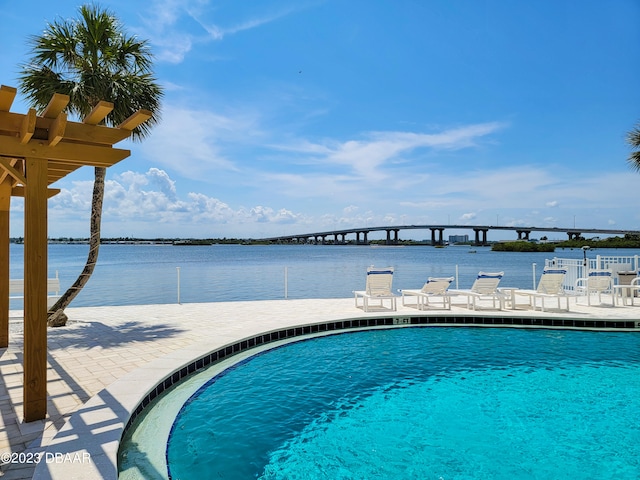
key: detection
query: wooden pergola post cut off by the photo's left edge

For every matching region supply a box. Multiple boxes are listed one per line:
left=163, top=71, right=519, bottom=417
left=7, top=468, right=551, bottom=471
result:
left=0, top=178, right=12, bottom=348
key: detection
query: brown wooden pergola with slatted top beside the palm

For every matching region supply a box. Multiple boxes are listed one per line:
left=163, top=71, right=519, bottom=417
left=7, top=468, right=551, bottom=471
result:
left=0, top=85, right=151, bottom=422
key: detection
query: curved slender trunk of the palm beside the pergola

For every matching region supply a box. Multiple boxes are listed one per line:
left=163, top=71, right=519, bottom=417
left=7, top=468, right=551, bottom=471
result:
left=48, top=167, right=107, bottom=326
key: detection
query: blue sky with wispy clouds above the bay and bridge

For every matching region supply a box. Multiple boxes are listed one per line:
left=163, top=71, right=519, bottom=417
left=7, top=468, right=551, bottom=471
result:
left=0, top=0, right=640, bottom=238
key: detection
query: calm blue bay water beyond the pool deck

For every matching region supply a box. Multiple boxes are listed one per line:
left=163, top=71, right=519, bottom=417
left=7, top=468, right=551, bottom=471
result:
left=10, top=244, right=640, bottom=309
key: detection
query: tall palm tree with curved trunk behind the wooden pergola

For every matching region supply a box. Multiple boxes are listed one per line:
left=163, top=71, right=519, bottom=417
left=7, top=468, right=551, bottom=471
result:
left=20, top=4, right=163, bottom=325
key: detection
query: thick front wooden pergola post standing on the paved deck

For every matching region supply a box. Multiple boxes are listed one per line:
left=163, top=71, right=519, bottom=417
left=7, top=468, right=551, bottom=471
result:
left=24, top=158, right=48, bottom=422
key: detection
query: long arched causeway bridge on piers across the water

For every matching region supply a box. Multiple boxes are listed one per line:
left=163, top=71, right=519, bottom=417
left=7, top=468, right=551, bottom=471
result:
left=259, top=225, right=640, bottom=246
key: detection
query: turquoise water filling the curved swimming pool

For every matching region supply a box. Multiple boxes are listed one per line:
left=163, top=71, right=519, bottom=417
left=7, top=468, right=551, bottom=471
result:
left=166, top=328, right=640, bottom=480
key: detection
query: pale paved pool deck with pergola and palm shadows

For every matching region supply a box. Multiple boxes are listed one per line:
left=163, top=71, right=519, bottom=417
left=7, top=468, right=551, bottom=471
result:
left=0, top=296, right=640, bottom=479
